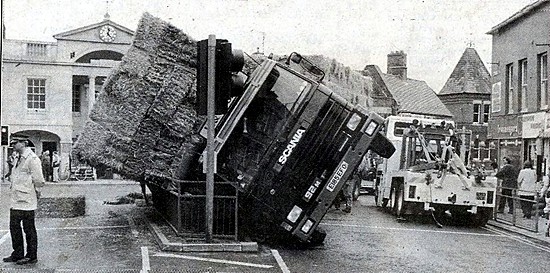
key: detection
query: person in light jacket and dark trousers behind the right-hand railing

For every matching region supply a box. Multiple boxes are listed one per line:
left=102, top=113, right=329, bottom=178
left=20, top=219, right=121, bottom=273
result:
left=518, top=160, right=537, bottom=219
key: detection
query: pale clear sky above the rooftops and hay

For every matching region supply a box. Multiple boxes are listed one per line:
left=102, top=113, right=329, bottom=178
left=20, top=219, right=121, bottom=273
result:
left=2, top=0, right=533, bottom=92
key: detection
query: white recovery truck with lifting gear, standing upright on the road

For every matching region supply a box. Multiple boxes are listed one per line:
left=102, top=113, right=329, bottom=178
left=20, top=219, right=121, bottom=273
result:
left=375, top=116, right=497, bottom=226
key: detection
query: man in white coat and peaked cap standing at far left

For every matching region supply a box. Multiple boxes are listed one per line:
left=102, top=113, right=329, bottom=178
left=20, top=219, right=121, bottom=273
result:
left=3, top=136, right=44, bottom=264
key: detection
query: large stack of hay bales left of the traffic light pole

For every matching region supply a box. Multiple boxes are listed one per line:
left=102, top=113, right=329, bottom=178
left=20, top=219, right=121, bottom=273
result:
left=74, top=13, right=202, bottom=183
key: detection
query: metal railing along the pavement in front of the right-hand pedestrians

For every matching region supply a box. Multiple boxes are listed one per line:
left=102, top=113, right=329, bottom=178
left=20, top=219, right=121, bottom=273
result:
left=493, top=186, right=542, bottom=233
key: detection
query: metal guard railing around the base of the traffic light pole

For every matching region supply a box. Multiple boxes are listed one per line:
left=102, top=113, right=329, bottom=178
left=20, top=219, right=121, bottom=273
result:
left=153, top=179, right=239, bottom=240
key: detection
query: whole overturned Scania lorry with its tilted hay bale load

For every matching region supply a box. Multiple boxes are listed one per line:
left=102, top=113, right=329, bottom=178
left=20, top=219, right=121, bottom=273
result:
left=75, top=14, right=395, bottom=243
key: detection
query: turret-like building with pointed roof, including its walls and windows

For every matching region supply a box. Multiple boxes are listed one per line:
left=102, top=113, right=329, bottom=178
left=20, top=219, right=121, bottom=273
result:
left=438, top=47, right=496, bottom=166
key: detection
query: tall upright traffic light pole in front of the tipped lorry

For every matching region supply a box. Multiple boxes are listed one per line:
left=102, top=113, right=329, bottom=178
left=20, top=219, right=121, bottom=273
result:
left=206, top=34, right=216, bottom=243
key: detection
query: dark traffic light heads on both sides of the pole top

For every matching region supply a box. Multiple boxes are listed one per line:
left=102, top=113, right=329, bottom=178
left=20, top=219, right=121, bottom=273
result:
left=196, top=39, right=244, bottom=115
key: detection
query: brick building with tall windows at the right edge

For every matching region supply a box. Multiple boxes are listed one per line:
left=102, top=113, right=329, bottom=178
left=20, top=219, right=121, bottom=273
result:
left=487, top=0, right=550, bottom=176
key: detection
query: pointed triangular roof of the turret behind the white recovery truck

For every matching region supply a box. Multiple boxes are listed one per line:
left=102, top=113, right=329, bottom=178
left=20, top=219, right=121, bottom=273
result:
left=439, top=47, right=491, bottom=95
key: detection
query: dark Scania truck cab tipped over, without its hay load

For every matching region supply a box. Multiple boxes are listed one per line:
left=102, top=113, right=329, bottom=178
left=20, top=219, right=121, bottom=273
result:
left=152, top=53, right=395, bottom=244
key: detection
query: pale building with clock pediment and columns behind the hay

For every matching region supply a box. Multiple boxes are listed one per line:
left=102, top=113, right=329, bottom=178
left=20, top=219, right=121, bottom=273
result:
left=1, top=14, right=134, bottom=176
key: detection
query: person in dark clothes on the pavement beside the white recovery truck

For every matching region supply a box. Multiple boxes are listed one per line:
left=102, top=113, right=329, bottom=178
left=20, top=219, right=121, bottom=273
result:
left=495, top=157, right=518, bottom=214
